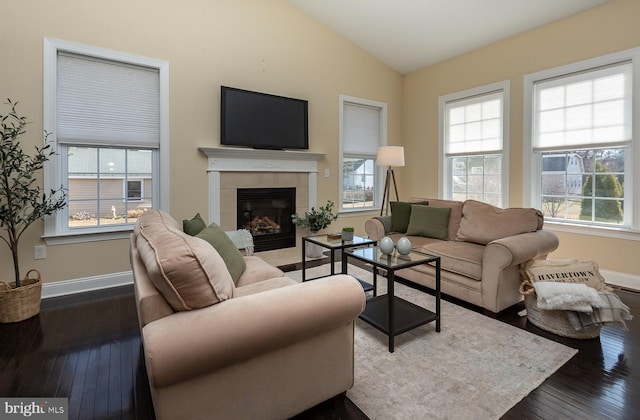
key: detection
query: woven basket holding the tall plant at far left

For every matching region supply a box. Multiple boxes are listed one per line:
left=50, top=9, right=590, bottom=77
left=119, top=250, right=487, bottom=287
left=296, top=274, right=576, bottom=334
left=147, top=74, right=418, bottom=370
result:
left=0, top=270, right=42, bottom=323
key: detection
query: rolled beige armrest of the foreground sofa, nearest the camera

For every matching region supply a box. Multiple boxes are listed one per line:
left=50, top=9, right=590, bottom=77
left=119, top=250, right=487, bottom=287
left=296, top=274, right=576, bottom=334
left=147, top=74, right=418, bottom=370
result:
left=142, top=275, right=366, bottom=387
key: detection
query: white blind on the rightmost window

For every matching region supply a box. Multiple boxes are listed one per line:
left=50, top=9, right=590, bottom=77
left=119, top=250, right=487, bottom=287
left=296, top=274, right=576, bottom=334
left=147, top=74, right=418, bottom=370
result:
left=533, top=62, right=632, bottom=151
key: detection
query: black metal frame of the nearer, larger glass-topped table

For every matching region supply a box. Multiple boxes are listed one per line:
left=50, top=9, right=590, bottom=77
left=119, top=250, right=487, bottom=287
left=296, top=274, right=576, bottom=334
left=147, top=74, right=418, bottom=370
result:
left=342, top=247, right=441, bottom=353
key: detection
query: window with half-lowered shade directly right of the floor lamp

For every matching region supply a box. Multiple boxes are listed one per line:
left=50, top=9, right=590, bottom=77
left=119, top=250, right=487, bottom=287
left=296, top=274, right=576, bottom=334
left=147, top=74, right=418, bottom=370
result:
left=439, top=82, right=509, bottom=207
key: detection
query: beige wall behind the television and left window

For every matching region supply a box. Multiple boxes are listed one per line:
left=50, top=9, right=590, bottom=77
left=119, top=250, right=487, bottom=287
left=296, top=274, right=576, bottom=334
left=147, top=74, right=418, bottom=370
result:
left=0, top=0, right=402, bottom=282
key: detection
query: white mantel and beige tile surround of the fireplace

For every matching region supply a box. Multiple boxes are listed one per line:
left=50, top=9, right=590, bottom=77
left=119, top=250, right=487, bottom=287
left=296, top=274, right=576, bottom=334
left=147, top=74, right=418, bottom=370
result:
left=200, top=147, right=325, bottom=259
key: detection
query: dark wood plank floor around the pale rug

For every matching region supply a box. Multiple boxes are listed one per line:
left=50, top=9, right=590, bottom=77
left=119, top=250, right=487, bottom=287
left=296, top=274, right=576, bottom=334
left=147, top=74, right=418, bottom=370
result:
left=0, top=265, right=640, bottom=420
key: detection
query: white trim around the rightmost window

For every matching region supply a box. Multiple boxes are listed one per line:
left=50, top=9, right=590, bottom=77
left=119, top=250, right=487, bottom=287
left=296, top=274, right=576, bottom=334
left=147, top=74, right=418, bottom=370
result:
left=522, top=47, right=640, bottom=241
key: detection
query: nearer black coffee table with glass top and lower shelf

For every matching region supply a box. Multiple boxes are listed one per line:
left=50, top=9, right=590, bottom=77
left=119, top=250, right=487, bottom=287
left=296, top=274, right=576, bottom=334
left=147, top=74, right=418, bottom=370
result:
left=342, top=246, right=440, bottom=353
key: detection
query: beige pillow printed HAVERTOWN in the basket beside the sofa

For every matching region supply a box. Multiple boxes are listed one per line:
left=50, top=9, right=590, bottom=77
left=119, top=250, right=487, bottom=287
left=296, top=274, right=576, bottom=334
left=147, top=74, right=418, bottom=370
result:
left=521, top=259, right=608, bottom=291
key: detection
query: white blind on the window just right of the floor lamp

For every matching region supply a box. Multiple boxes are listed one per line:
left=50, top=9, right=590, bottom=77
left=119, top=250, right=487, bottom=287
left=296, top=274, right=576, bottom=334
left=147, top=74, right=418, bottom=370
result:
left=445, top=91, right=503, bottom=156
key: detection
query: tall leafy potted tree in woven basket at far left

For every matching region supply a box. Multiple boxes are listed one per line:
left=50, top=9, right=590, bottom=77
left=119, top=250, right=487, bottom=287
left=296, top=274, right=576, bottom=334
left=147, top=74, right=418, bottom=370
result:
left=0, top=100, right=66, bottom=322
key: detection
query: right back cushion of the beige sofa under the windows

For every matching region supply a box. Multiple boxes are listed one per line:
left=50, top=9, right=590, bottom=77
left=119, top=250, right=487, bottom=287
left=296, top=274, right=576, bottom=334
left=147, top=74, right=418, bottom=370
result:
left=456, top=200, right=544, bottom=245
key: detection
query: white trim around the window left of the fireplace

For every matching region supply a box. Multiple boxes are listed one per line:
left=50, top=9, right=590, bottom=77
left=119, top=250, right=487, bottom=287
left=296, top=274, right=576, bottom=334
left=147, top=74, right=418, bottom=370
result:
left=43, top=37, right=169, bottom=245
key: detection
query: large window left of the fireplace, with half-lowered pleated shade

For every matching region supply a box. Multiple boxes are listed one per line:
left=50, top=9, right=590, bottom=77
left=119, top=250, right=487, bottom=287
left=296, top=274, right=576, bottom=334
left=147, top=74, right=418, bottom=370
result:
left=45, top=39, right=168, bottom=243
